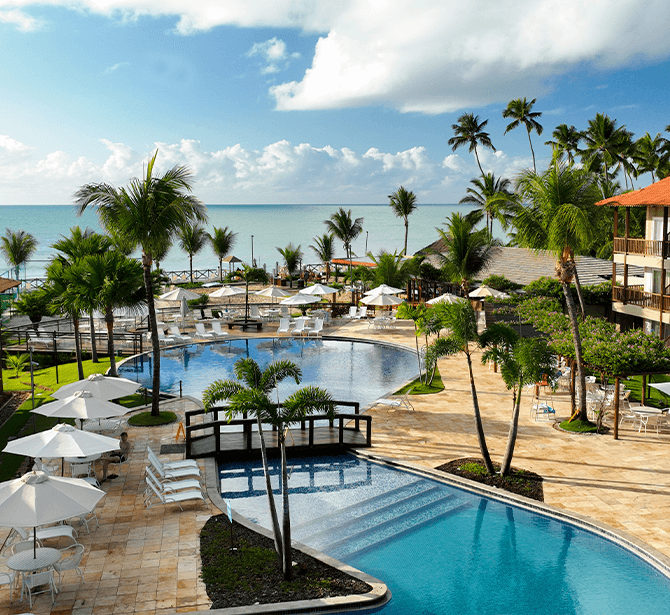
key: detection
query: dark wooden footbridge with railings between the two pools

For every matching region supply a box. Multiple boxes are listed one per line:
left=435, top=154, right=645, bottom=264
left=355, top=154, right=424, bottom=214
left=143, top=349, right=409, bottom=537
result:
left=185, top=401, right=372, bottom=460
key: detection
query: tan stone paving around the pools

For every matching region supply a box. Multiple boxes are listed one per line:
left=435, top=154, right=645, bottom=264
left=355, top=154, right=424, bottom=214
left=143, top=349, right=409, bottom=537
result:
left=0, top=322, right=670, bottom=615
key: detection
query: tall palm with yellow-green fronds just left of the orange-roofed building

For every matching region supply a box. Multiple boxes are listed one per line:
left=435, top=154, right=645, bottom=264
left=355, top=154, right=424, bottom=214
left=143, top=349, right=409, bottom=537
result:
left=514, top=159, right=601, bottom=421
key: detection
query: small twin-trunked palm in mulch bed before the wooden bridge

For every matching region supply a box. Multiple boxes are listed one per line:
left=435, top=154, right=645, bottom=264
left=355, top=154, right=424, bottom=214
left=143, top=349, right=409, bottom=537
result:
left=202, top=358, right=334, bottom=581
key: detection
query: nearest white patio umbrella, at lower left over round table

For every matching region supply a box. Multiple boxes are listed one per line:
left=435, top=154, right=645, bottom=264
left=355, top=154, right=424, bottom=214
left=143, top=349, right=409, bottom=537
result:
left=0, top=471, right=105, bottom=557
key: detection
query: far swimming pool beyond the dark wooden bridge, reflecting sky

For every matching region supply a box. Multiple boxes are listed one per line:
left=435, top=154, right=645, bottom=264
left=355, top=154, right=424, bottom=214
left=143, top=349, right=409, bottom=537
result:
left=119, top=338, right=418, bottom=408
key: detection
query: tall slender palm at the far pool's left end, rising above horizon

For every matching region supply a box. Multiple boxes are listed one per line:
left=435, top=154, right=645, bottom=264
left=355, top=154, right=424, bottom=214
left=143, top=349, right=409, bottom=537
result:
left=75, top=151, right=207, bottom=416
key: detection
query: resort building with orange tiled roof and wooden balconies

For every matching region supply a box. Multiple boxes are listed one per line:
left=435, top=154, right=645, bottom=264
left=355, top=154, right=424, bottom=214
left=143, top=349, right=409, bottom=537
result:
left=597, top=177, right=670, bottom=338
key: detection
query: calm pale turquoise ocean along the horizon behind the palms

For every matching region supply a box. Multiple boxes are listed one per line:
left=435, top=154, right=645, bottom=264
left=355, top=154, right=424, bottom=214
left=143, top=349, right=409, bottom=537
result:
left=0, top=204, right=503, bottom=278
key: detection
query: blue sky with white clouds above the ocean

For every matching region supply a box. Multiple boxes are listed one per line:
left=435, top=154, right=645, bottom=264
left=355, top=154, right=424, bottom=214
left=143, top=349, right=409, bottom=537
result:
left=0, top=0, right=670, bottom=205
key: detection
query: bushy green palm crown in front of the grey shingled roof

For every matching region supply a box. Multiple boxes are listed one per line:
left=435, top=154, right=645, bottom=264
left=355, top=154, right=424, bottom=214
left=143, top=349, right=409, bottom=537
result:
left=436, top=213, right=496, bottom=296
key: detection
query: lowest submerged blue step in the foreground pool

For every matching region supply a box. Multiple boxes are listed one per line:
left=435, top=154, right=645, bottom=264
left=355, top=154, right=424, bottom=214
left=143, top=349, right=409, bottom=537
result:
left=320, top=496, right=471, bottom=562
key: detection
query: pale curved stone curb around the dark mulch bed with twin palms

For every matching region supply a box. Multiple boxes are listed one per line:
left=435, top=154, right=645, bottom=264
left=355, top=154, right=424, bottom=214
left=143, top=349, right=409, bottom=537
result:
left=205, top=457, right=391, bottom=615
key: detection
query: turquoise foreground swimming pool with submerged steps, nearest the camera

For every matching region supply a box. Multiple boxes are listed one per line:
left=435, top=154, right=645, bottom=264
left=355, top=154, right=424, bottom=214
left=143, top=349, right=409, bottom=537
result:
left=220, top=455, right=670, bottom=615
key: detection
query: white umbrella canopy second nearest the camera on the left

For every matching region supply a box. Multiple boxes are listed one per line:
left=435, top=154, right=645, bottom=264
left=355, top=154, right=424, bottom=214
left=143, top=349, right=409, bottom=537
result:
left=2, top=425, right=119, bottom=460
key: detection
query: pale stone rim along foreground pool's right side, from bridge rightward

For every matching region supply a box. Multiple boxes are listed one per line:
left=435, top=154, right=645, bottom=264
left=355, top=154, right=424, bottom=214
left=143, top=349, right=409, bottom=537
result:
left=350, top=450, right=670, bottom=579
